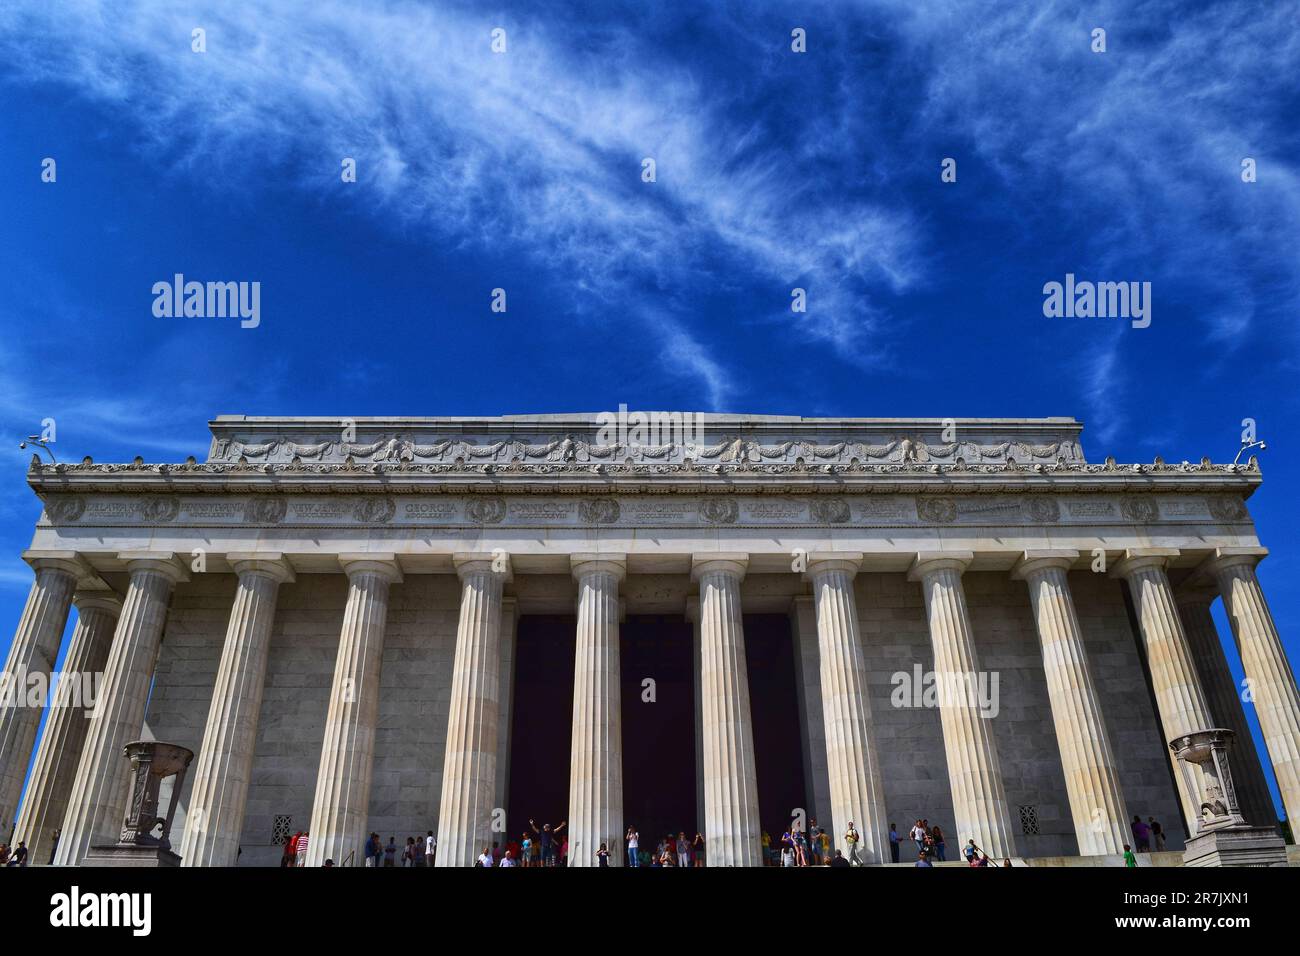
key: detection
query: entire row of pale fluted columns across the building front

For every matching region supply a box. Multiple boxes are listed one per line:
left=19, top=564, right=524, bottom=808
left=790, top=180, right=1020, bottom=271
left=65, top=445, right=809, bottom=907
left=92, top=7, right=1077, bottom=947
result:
left=0, top=548, right=1300, bottom=866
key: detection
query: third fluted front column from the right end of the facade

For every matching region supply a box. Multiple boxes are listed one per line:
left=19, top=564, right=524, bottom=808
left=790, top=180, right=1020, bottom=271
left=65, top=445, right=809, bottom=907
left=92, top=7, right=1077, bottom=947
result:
left=1011, top=550, right=1131, bottom=856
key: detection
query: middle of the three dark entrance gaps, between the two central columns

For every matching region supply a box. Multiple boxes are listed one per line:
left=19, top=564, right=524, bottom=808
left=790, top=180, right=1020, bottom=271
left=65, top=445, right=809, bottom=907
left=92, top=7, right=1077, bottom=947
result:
left=620, top=615, right=703, bottom=849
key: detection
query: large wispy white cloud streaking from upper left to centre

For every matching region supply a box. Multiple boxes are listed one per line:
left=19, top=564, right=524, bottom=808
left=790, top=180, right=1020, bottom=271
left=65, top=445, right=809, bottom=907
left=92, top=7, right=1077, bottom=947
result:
left=0, top=0, right=917, bottom=401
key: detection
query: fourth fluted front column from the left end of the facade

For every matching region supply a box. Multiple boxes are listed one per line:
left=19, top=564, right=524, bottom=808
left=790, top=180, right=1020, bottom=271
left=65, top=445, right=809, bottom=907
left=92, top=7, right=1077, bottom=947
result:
left=307, top=553, right=402, bottom=866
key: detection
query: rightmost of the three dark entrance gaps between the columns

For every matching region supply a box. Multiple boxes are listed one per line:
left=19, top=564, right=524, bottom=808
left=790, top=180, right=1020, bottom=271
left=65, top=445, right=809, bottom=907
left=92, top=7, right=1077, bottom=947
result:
left=745, top=614, right=806, bottom=845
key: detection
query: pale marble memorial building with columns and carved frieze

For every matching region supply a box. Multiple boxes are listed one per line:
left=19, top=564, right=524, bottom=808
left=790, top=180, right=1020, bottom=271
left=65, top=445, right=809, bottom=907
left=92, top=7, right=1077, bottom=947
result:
left=0, top=415, right=1300, bottom=866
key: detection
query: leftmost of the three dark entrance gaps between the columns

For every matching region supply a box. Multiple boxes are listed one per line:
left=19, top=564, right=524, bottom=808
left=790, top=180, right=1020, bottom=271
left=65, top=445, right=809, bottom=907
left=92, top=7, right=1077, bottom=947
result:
left=506, top=614, right=577, bottom=840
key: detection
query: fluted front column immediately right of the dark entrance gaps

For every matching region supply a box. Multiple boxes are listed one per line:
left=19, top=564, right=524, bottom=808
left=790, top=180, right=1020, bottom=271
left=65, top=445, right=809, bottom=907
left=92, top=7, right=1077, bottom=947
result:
left=807, top=554, right=889, bottom=864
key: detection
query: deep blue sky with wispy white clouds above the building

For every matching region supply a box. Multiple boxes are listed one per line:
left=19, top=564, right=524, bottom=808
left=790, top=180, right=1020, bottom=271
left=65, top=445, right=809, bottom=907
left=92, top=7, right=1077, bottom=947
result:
left=0, top=0, right=1300, bottom=822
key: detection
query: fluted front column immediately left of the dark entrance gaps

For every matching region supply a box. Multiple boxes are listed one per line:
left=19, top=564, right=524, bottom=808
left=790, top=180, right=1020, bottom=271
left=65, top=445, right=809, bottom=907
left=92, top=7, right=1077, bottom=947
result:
left=434, top=553, right=510, bottom=866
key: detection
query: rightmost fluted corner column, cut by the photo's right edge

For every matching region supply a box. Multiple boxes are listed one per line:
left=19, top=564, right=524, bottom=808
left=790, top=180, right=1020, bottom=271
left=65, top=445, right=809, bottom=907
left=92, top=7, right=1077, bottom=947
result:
left=1210, top=548, right=1300, bottom=827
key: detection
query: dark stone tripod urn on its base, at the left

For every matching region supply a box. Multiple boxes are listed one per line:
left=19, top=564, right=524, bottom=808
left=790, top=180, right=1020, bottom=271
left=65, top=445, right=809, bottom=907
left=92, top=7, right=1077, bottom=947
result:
left=82, top=740, right=194, bottom=866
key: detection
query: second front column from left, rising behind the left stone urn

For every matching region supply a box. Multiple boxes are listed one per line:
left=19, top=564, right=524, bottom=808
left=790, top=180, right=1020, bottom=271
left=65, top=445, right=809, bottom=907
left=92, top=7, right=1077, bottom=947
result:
left=55, top=551, right=190, bottom=866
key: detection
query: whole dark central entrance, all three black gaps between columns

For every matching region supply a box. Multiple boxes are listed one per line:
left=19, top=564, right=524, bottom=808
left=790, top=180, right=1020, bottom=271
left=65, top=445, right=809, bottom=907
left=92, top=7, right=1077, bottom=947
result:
left=507, top=614, right=800, bottom=868
